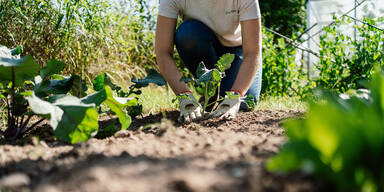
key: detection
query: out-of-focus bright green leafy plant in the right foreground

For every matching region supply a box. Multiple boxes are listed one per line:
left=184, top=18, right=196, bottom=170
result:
left=267, top=72, right=384, bottom=191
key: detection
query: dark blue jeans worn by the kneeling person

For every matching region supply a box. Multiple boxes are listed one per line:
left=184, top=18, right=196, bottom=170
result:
left=175, top=20, right=262, bottom=103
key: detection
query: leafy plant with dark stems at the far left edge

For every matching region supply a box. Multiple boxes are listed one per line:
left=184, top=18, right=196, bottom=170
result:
left=0, top=46, right=40, bottom=138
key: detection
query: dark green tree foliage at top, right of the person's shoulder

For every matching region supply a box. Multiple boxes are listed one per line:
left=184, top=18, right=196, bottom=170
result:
left=259, top=0, right=307, bottom=37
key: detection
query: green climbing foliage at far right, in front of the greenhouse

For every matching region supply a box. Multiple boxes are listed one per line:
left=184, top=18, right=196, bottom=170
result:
left=315, top=17, right=384, bottom=92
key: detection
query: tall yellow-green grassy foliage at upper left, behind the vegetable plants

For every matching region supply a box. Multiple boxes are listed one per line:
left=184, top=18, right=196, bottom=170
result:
left=0, top=0, right=155, bottom=84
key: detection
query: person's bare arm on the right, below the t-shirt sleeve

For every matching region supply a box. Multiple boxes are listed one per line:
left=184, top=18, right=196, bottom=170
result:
left=231, top=19, right=262, bottom=95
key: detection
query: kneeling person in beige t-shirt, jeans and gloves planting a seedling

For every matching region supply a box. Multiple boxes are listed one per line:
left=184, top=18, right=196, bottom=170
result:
left=155, top=0, right=262, bottom=121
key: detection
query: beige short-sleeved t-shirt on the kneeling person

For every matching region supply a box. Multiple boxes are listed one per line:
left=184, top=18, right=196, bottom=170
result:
left=159, top=0, right=261, bottom=47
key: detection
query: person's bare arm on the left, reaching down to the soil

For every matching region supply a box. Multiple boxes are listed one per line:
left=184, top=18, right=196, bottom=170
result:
left=155, top=15, right=190, bottom=94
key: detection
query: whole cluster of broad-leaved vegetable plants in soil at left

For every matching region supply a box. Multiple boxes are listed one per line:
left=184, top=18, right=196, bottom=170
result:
left=0, top=47, right=137, bottom=143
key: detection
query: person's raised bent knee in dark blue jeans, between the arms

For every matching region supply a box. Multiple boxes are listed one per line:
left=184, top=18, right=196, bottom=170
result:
left=175, top=20, right=218, bottom=75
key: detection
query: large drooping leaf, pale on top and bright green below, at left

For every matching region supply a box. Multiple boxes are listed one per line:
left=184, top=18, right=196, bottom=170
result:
left=27, top=95, right=98, bottom=143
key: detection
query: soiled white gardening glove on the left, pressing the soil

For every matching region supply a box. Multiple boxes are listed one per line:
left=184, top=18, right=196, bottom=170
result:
left=177, top=93, right=202, bottom=123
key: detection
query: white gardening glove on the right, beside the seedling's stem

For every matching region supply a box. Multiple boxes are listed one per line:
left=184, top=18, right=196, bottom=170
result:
left=209, top=91, right=242, bottom=120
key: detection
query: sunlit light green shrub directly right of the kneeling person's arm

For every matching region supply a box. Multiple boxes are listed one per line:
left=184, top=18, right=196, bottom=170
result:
left=261, top=30, right=313, bottom=96
